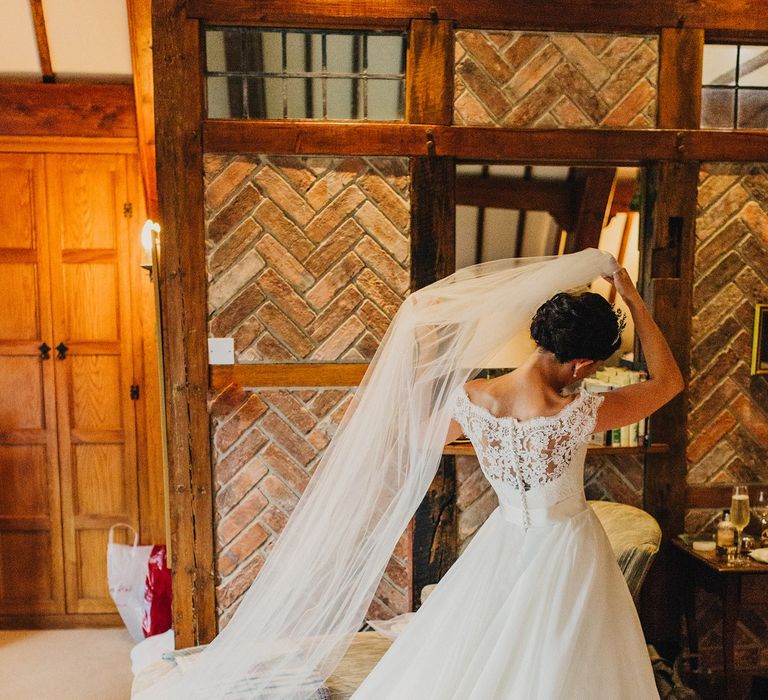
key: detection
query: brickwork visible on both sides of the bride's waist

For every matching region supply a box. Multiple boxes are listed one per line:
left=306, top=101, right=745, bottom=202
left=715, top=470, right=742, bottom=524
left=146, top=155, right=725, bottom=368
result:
left=456, top=455, right=643, bottom=550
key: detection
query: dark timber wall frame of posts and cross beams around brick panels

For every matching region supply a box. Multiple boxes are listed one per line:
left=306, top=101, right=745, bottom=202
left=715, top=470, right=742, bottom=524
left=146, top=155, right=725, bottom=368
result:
left=153, top=0, right=768, bottom=646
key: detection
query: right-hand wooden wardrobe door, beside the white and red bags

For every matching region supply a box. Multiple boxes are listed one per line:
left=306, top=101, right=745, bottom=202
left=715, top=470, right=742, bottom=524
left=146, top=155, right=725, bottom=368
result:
left=46, top=154, right=138, bottom=613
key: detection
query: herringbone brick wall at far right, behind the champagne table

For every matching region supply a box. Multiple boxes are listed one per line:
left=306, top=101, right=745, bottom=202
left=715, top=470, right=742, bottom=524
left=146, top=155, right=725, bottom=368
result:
left=686, top=163, right=768, bottom=668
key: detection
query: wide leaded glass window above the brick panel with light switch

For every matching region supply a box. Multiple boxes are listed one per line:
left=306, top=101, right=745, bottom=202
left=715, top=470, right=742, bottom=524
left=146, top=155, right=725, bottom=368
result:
left=205, top=27, right=406, bottom=121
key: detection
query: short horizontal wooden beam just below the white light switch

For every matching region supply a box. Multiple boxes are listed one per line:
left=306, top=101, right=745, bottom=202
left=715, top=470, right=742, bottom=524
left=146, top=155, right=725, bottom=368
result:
left=210, top=362, right=368, bottom=391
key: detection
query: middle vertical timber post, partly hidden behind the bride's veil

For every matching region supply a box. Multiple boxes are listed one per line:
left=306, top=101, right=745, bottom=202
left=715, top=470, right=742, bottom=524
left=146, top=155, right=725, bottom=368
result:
left=405, top=19, right=457, bottom=608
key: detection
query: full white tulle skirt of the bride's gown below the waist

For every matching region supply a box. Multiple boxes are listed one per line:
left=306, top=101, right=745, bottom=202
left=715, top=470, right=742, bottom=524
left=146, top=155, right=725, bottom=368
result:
left=353, top=508, right=659, bottom=700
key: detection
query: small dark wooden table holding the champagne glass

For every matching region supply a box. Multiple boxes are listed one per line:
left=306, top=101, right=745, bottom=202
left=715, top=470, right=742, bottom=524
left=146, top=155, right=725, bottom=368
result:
left=672, top=537, right=768, bottom=698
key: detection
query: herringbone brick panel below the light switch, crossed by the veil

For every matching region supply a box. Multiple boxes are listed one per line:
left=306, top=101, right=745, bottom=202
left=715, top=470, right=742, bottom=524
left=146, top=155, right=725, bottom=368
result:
left=210, top=385, right=411, bottom=624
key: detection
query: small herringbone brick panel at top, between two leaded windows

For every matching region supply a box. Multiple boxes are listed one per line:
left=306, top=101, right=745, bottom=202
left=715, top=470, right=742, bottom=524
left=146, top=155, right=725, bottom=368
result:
left=453, top=30, right=659, bottom=129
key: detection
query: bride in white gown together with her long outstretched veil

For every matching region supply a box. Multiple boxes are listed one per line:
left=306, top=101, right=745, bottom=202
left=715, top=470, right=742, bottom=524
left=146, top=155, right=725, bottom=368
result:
left=137, top=249, right=682, bottom=700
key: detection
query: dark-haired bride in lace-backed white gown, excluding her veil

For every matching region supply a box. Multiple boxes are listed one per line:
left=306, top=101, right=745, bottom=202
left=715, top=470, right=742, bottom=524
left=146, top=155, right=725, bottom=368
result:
left=353, top=269, right=683, bottom=700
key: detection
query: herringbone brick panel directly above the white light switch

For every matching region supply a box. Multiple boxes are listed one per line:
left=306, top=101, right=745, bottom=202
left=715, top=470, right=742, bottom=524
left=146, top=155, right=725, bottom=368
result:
left=204, top=154, right=410, bottom=362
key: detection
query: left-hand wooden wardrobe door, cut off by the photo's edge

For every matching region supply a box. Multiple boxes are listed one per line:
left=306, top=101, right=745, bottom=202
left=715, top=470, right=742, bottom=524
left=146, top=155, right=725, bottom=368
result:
left=0, top=153, right=64, bottom=615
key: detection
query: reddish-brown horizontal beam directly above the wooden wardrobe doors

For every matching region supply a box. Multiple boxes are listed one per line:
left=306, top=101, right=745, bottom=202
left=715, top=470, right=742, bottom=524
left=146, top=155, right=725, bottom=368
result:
left=0, top=80, right=136, bottom=138
